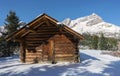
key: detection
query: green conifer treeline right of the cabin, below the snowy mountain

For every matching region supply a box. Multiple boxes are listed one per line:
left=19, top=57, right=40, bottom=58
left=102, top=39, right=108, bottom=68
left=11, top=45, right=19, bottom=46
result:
left=80, top=33, right=118, bottom=51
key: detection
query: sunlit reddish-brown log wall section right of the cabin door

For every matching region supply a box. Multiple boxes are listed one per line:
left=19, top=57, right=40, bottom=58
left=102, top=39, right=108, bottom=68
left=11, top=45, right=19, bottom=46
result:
left=51, top=34, right=75, bottom=62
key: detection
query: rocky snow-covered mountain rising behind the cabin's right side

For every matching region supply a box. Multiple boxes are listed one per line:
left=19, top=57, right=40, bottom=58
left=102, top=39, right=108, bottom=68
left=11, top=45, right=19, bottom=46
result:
left=62, top=13, right=120, bottom=38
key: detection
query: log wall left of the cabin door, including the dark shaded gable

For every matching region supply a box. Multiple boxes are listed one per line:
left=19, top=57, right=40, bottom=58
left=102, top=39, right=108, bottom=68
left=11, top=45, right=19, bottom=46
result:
left=24, top=24, right=59, bottom=63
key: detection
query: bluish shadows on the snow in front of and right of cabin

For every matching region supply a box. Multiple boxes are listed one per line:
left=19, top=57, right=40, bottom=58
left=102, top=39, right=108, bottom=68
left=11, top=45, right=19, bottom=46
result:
left=0, top=53, right=120, bottom=76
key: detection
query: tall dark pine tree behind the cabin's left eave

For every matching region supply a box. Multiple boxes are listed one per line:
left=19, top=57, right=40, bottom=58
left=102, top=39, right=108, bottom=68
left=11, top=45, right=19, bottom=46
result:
left=2, top=11, right=20, bottom=56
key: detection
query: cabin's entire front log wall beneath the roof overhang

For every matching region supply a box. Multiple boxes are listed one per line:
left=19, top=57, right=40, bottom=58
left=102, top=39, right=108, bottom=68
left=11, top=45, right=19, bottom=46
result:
left=20, top=22, right=77, bottom=63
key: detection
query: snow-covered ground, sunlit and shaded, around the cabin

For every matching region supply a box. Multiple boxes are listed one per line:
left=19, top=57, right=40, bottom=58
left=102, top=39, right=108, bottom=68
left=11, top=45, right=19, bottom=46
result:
left=0, top=50, right=120, bottom=76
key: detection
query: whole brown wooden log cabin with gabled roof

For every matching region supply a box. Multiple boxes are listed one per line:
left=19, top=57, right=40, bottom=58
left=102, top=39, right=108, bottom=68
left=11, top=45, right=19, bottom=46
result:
left=6, top=13, right=84, bottom=63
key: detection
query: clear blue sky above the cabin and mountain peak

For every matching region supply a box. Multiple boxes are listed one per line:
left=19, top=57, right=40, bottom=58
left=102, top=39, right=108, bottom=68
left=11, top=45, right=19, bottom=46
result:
left=0, top=0, right=120, bottom=25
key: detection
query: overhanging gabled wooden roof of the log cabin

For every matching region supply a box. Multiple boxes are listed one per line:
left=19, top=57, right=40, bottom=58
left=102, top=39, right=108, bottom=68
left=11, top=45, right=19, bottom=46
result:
left=6, top=13, right=84, bottom=41
